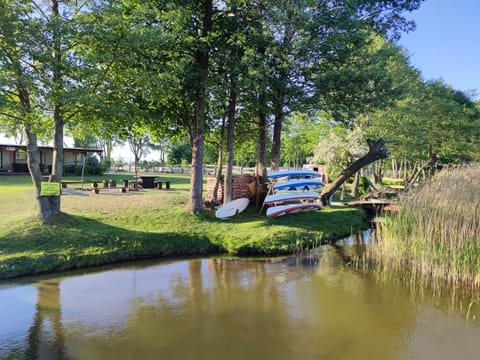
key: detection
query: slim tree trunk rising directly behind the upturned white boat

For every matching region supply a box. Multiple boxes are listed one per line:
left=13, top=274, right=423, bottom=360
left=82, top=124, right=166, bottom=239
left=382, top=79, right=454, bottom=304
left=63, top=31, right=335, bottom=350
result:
left=223, top=77, right=237, bottom=204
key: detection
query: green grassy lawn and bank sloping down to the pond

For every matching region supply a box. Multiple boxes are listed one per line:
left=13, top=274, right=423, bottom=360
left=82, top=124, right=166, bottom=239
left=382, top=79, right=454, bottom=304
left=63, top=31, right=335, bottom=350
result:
left=0, top=174, right=365, bottom=278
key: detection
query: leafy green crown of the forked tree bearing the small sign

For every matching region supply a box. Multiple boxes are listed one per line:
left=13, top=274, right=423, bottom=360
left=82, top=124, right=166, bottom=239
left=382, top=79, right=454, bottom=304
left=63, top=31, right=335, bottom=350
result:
left=0, top=0, right=114, bottom=137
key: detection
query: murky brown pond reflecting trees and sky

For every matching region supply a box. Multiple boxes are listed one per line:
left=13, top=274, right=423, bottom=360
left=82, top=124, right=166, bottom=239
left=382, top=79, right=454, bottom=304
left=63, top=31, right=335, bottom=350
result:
left=0, top=239, right=480, bottom=360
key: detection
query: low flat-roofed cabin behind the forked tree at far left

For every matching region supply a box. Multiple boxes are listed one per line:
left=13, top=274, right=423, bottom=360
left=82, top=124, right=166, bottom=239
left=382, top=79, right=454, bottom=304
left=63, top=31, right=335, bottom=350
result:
left=0, top=144, right=103, bottom=174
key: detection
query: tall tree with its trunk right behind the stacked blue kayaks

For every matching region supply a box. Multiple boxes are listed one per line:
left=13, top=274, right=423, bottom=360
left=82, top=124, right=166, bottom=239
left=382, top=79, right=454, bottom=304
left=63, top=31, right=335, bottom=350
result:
left=269, top=0, right=420, bottom=169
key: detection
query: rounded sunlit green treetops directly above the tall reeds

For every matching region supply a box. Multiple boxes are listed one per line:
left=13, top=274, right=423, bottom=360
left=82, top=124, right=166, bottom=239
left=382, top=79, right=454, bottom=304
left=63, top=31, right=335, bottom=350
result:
left=363, top=81, right=480, bottom=165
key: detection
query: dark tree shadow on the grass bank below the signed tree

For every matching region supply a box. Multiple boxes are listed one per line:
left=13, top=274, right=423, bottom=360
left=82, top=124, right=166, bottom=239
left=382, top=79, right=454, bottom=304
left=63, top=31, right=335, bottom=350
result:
left=0, top=214, right=223, bottom=279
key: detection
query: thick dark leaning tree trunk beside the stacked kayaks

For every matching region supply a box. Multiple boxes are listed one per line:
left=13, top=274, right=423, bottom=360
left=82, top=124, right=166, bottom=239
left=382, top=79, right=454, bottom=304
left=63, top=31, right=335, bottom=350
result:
left=320, top=138, right=388, bottom=205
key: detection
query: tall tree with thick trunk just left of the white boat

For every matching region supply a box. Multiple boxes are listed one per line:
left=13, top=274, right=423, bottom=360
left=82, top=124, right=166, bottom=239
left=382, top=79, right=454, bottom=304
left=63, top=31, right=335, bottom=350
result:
left=110, top=0, right=214, bottom=213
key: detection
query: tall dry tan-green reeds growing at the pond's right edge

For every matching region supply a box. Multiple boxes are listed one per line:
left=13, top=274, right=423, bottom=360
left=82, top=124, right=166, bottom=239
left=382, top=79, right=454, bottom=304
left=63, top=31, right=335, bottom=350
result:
left=373, top=163, right=480, bottom=290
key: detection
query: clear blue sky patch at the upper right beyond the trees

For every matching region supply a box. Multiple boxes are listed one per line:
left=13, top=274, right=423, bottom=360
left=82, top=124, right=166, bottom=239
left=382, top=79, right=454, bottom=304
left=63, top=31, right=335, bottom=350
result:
left=399, top=0, right=480, bottom=99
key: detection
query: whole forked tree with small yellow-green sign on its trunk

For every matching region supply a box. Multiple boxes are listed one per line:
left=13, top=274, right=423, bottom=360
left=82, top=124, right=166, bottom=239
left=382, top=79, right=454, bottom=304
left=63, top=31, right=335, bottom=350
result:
left=0, top=0, right=110, bottom=220
